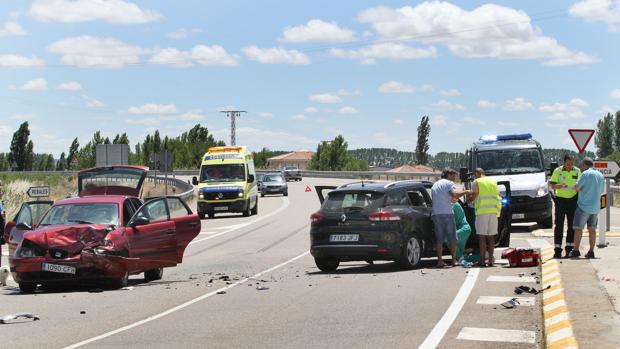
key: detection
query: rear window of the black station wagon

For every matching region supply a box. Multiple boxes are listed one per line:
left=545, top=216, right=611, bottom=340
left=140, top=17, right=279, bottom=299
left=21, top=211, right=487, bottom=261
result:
left=322, top=191, right=384, bottom=212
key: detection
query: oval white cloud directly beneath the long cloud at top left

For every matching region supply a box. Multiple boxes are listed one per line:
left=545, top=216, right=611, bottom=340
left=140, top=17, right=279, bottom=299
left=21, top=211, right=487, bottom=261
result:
left=48, top=35, right=148, bottom=69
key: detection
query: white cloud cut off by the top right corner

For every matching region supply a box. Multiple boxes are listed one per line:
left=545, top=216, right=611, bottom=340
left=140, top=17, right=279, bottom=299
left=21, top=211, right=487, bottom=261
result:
left=568, top=0, right=620, bottom=31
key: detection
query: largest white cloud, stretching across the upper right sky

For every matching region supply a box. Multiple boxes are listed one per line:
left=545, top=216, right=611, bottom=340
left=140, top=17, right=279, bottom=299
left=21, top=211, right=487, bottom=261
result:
left=358, top=1, right=599, bottom=66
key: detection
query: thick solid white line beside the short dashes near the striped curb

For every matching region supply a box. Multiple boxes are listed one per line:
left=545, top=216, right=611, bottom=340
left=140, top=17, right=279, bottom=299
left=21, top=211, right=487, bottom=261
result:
left=418, top=268, right=480, bottom=349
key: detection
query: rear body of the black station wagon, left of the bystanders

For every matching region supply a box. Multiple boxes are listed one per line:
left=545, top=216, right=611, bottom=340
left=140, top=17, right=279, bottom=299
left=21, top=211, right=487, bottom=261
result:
left=310, top=181, right=435, bottom=271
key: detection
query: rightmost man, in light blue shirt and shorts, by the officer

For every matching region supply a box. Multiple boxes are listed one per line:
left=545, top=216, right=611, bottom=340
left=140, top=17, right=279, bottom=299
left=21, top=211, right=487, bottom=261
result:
left=570, top=158, right=605, bottom=258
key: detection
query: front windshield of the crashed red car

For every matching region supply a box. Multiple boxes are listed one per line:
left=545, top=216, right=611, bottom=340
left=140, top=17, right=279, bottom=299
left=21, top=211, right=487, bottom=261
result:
left=40, top=203, right=118, bottom=225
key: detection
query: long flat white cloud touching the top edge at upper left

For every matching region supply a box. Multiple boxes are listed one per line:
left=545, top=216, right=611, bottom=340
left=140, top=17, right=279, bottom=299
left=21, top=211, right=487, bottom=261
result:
left=29, top=0, right=164, bottom=24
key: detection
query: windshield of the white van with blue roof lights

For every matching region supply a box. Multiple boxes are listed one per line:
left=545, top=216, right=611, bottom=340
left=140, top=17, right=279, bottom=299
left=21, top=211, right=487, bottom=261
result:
left=477, top=148, right=544, bottom=175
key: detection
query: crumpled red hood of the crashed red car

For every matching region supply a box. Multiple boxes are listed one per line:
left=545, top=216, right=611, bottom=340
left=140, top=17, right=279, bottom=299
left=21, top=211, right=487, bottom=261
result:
left=24, top=224, right=111, bottom=254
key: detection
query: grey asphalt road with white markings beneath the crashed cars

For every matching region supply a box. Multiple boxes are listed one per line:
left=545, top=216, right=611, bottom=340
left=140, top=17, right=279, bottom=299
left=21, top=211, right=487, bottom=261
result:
left=0, top=179, right=542, bottom=348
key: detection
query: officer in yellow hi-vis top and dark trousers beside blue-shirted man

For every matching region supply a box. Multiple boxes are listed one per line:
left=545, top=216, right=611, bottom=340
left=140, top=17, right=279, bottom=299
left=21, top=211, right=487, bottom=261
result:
left=549, top=154, right=581, bottom=258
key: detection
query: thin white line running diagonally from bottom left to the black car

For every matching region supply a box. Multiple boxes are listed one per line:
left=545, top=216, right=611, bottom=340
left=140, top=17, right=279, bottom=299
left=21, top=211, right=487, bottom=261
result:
left=63, top=251, right=310, bottom=349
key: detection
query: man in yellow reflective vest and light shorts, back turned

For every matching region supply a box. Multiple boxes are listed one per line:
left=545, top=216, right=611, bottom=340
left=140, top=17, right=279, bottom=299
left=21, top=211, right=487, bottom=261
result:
left=470, top=168, right=502, bottom=267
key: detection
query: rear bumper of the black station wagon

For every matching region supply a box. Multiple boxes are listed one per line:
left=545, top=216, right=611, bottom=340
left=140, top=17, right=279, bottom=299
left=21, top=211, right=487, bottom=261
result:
left=310, top=244, right=401, bottom=261
